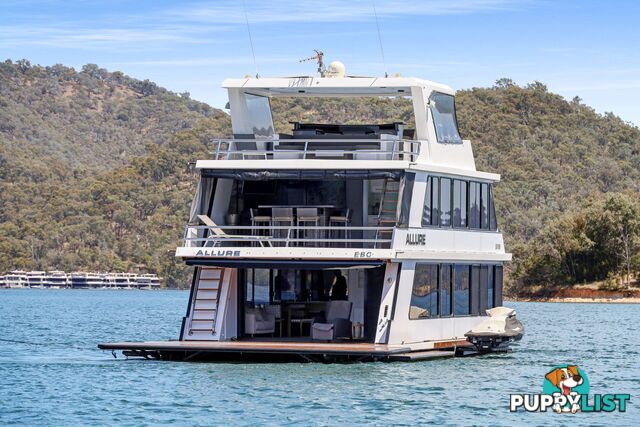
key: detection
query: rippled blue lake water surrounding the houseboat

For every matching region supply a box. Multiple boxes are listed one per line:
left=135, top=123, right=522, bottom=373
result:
left=0, top=290, right=640, bottom=426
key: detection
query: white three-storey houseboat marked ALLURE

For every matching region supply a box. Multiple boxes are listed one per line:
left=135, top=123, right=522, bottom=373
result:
left=99, top=69, right=522, bottom=361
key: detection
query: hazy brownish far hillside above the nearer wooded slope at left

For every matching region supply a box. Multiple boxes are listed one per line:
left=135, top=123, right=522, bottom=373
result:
left=0, top=60, right=229, bottom=177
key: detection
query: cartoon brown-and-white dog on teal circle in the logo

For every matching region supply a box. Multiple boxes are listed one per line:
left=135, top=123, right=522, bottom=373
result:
left=544, top=365, right=589, bottom=414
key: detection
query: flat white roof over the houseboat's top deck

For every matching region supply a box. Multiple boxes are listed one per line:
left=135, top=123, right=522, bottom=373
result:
left=222, top=76, right=454, bottom=96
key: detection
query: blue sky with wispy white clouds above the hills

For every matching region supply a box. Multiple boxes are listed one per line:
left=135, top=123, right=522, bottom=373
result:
left=0, top=0, right=640, bottom=125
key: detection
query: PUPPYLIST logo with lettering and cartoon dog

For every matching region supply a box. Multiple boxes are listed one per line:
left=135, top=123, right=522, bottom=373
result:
left=509, top=365, right=631, bottom=414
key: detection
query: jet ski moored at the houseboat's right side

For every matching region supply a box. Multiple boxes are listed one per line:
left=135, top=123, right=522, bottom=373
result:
left=464, top=307, right=524, bottom=353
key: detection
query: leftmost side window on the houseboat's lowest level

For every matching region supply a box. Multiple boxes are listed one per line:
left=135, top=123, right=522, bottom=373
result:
left=409, top=264, right=438, bottom=320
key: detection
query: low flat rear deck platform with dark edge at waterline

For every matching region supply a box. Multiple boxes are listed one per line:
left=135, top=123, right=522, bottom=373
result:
left=98, top=340, right=473, bottom=362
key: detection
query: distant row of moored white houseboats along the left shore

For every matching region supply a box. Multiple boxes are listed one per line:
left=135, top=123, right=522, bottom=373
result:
left=0, top=270, right=160, bottom=289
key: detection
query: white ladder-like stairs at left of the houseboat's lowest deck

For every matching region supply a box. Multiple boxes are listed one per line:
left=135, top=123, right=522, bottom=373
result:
left=188, top=267, right=225, bottom=336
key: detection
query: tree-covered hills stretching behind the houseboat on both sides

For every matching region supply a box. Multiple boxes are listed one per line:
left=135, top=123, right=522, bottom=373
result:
left=0, top=61, right=640, bottom=286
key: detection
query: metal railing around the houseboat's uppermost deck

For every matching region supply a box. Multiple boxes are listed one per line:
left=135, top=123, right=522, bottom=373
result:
left=209, top=138, right=421, bottom=161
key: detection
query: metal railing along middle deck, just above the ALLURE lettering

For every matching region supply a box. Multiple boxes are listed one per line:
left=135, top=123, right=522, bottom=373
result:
left=183, top=225, right=394, bottom=249
